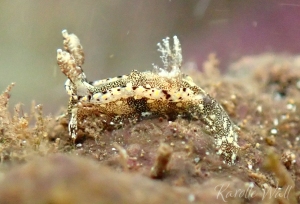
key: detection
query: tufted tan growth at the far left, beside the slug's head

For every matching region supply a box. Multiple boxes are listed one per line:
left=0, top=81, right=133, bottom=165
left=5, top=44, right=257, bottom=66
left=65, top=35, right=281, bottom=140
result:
left=0, top=84, right=62, bottom=163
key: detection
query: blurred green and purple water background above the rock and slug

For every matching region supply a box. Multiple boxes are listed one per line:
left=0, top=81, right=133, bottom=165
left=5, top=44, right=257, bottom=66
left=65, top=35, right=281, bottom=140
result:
left=0, top=0, right=300, bottom=115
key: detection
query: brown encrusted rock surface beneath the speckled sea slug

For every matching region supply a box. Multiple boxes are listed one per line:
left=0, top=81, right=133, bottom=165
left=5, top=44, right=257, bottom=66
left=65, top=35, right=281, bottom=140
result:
left=0, top=54, right=300, bottom=204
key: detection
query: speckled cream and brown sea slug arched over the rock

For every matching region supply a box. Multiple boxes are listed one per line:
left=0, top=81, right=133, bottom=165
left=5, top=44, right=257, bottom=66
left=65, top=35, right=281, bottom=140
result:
left=57, top=30, right=239, bottom=164
